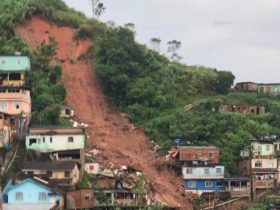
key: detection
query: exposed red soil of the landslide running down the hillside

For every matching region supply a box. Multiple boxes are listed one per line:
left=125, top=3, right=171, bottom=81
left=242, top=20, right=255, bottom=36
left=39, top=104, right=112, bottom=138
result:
left=16, top=17, right=192, bottom=209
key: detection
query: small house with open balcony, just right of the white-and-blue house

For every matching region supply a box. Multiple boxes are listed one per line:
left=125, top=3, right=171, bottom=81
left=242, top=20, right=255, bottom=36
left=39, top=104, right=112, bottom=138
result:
left=225, top=176, right=251, bottom=200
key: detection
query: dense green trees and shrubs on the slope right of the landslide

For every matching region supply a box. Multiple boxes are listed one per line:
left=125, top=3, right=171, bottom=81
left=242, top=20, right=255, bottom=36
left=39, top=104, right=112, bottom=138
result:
left=94, top=27, right=280, bottom=173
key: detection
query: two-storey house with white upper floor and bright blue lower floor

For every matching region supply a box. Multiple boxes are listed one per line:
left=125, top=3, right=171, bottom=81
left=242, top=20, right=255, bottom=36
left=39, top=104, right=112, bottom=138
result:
left=182, top=165, right=225, bottom=195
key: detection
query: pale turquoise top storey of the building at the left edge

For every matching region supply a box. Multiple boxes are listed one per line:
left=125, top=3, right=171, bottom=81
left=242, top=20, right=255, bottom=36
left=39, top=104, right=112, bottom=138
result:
left=0, top=55, right=31, bottom=72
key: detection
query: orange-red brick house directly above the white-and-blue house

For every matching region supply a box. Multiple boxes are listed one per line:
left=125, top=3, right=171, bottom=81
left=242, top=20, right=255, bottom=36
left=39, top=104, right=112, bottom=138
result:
left=169, top=146, right=220, bottom=164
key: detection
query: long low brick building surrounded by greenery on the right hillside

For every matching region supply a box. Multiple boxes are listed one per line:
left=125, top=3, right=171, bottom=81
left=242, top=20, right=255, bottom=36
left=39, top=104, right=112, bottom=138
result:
left=220, top=104, right=265, bottom=116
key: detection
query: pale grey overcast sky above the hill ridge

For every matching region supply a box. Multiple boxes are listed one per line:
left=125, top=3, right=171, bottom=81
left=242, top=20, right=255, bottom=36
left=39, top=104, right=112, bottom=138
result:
left=64, top=0, right=280, bottom=82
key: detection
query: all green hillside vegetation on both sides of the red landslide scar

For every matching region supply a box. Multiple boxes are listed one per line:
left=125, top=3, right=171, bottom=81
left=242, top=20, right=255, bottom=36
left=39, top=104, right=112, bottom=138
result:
left=0, top=0, right=280, bottom=176
